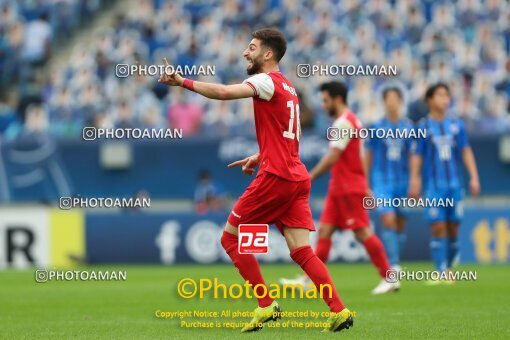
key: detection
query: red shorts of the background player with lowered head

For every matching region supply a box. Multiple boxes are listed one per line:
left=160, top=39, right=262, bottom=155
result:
left=321, top=194, right=370, bottom=230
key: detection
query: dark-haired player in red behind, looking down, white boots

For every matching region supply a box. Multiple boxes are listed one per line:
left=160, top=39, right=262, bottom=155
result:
left=281, top=82, right=400, bottom=294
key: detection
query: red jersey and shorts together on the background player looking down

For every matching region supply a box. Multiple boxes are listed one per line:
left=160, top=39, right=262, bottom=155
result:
left=321, top=111, right=370, bottom=229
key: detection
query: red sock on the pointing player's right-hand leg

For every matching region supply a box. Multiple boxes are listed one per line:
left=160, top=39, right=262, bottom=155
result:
left=290, top=246, right=345, bottom=313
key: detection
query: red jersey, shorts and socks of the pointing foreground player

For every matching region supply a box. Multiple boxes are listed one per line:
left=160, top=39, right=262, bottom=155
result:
left=221, top=72, right=345, bottom=313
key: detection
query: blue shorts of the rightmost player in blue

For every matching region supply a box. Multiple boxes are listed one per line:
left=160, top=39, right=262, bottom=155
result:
left=424, top=189, right=464, bottom=223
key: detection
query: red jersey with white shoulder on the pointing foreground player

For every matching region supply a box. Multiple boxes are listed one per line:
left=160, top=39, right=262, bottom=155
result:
left=244, top=72, right=310, bottom=182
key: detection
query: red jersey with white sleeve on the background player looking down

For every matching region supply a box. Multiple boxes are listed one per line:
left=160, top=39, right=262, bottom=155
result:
left=328, top=111, right=368, bottom=196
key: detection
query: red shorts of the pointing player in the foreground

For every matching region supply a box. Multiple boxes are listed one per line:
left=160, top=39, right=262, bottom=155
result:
left=228, top=172, right=315, bottom=232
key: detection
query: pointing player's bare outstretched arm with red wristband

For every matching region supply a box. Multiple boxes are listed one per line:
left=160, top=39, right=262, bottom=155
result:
left=158, top=58, right=255, bottom=100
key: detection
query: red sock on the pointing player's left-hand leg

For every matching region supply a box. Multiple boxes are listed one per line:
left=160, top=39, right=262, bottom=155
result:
left=221, top=231, right=273, bottom=307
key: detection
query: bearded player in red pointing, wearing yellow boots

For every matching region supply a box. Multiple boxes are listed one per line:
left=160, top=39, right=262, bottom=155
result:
left=159, top=28, right=353, bottom=332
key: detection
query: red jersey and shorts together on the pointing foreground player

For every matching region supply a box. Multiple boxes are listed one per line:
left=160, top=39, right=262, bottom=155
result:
left=228, top=72, right=315, bottom=231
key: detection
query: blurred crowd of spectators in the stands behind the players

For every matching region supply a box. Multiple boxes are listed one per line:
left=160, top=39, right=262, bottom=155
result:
left=0, top=0, right=510, bottom=140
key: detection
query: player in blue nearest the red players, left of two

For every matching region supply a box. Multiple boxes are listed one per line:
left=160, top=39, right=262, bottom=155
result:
left=365, top=87, right=413, bottom=270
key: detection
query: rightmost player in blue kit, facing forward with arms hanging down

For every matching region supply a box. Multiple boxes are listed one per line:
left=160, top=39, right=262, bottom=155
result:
left=409, top=83, right=480, bottom=278
